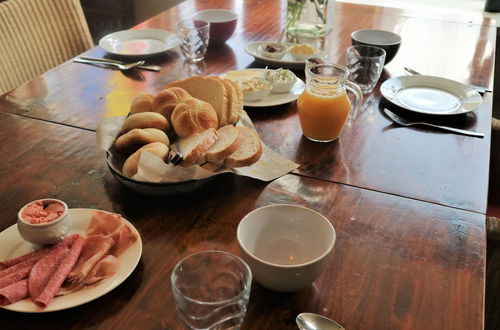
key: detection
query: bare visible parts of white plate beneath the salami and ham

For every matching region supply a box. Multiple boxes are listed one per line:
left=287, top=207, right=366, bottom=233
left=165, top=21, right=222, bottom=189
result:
left=0, top=209, right=142, bottom=313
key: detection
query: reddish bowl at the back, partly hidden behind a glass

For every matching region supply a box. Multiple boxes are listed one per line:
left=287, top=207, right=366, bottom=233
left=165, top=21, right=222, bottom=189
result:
left=194, top=9, right=238, bottom=44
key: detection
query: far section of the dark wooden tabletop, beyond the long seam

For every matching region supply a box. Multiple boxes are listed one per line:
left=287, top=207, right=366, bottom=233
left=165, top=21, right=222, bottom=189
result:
left=0, top=0, right=496, bottom=213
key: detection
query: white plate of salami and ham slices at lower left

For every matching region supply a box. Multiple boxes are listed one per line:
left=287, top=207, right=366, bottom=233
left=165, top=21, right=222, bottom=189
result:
left=0, top=209, right=142, bottom=313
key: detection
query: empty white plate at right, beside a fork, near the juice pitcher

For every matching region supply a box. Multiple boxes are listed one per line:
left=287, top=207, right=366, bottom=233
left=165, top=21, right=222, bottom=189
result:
left=380, top=75, right=483, bottom=115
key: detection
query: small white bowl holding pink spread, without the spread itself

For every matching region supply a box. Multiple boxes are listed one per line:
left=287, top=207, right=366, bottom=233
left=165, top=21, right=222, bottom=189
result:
left=17, top=198, right=72, bottom=245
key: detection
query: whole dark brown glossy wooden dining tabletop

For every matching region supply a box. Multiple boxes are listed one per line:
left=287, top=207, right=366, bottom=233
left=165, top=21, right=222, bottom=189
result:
left=0, top=0, right=496, bottom=329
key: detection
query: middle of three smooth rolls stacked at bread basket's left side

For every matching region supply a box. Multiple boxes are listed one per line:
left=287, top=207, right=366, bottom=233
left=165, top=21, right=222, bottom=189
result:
left=115, top=128, right=170, bottom=153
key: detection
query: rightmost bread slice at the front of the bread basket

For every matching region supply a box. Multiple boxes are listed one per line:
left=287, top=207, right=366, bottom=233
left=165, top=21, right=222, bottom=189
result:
left=224, top=126, right=262, bottom=168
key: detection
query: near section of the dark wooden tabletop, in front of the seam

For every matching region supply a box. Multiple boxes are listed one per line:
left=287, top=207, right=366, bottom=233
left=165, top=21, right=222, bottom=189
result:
left=0, top=113, right=486, bottom=329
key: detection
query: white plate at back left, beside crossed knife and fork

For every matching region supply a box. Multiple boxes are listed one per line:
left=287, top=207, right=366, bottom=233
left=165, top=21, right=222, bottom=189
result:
left=99, top=29, right=179, bottom=57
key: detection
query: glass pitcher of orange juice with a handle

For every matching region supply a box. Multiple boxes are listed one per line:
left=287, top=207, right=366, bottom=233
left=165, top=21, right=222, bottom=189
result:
left=297, top=63, right=363, bottom=142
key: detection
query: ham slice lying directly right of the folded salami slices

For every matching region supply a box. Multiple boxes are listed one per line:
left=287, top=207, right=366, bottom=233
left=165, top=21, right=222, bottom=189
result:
left=66, top=236, right=114, bottom=282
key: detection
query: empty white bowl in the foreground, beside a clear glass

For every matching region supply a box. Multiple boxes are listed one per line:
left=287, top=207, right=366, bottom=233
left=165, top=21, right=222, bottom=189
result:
left=237, top=204, right=336, bottom=292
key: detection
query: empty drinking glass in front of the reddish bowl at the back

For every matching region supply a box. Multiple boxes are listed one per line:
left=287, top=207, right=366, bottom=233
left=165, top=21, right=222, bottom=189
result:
left=177, top=18, right=210, bottom=63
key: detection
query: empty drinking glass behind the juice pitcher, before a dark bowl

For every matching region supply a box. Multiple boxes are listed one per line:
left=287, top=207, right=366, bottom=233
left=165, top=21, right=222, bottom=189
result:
left=347, top=45, right=386, bottom=93
